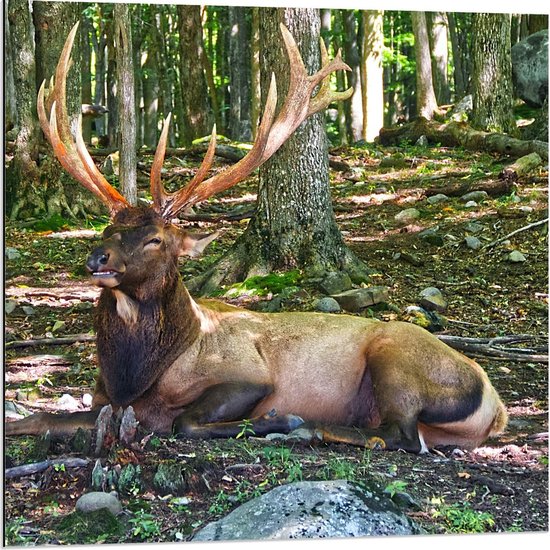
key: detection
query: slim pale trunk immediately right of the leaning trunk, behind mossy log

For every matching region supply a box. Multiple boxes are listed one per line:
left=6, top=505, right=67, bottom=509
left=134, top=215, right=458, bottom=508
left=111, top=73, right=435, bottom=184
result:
left=428, top=12, right=451, bottom=105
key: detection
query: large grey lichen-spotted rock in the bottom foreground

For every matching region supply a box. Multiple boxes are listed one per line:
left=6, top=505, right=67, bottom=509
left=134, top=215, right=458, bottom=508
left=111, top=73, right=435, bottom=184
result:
left=193, top=480, right=423, bottom=541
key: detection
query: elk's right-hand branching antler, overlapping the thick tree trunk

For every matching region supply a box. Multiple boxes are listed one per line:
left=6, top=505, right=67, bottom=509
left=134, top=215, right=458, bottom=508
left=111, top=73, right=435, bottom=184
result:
left=151, top=23, right=353, bottom=219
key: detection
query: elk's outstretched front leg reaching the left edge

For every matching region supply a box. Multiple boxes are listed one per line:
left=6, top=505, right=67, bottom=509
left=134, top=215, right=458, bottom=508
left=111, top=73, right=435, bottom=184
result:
left=4, top=407, right=101, bottom=437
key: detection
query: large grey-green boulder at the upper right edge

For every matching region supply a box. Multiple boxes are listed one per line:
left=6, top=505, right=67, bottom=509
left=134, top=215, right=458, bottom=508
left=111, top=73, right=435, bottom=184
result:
left=512, top=29, right=548, bottom=107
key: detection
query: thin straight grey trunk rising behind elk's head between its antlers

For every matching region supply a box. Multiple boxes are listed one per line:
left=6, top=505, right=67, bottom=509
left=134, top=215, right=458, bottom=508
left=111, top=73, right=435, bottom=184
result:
left=113, top=4, right=137, bottom=205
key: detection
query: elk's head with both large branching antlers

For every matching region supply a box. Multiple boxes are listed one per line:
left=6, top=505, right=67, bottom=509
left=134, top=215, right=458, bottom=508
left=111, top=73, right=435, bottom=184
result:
left=37, top=23, right=353, bottom=296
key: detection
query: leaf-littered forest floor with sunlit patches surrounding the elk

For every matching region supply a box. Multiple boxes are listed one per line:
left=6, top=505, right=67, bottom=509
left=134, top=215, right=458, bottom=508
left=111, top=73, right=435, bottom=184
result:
left=4, top=139, right=548, bottom=545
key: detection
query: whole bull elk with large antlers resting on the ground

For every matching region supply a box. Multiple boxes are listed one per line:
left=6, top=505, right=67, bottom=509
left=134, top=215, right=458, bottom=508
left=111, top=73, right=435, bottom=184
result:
left=6, top=25, right=507, bottom=452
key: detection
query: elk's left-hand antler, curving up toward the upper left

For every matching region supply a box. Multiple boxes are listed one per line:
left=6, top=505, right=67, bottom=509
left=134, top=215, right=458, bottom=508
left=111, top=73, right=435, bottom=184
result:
left=37, top=23, right=129, bottom=215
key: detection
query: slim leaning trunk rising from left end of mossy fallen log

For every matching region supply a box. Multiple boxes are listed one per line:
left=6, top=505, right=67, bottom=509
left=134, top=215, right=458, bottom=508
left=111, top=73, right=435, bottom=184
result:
left=411, top=11, right=437, bottom=120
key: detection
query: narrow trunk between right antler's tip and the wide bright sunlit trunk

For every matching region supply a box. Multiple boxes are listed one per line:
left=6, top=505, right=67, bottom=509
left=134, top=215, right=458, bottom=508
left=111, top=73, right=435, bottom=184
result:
left=343, top=10, right=363, bottom=142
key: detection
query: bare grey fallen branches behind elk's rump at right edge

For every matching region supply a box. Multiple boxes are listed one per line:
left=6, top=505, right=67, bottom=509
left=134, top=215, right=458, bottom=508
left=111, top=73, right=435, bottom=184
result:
left=438, top=334, right=548, bottom=363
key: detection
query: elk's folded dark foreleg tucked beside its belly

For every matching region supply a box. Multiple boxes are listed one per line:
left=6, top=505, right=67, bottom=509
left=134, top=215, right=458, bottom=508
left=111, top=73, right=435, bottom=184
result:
left=173, top=382, right=303, bottom=439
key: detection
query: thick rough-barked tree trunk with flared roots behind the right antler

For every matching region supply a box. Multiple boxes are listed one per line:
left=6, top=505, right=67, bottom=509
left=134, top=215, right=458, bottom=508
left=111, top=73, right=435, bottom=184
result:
left=191, top=8, right=366, bottom=293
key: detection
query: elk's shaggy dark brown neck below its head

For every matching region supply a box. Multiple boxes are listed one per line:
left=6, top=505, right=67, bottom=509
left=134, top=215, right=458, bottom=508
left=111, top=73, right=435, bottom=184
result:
left=95, top=266, right=201, bottom=406
